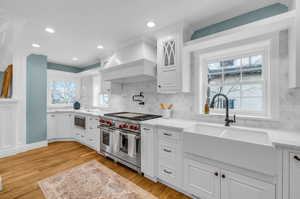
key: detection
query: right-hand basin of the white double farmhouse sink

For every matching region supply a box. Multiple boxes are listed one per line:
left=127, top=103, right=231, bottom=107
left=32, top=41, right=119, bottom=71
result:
left=221, top=129, right=272, bottom=146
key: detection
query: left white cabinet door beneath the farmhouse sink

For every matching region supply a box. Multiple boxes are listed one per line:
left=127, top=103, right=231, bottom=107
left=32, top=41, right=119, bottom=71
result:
left=184, top=159, right=221, bottom=199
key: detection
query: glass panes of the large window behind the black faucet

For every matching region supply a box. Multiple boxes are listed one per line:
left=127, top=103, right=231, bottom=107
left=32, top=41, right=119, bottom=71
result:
left=207, top=53, right=265, bottom=112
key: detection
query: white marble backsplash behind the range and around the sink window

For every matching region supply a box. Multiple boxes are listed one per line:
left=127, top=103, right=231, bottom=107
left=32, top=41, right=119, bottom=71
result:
left=106, top=31, right=300, bottom=133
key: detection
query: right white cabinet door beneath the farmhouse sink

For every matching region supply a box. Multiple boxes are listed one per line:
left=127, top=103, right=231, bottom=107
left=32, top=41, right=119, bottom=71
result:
left=221, top=171, right=276, bottom=199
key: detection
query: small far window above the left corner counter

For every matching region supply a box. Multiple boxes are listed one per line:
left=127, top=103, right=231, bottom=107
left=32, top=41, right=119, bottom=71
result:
left=50, top=81, right=76, bottom=105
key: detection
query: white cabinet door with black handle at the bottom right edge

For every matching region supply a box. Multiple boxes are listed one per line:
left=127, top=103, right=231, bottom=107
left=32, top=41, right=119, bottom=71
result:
left=289, top=153, right=300, bottom=199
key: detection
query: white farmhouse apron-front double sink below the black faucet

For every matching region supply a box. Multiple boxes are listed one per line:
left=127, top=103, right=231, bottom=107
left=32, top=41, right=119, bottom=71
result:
left=183, top=123, right=277, bottom=176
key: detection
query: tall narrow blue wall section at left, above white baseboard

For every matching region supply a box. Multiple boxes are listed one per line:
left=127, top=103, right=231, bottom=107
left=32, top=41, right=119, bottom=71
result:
left=26, top=55, right=47, bottom=144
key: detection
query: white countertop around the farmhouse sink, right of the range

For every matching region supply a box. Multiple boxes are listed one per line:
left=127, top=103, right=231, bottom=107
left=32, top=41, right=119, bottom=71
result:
left=142, top=118, right=300, bottom=150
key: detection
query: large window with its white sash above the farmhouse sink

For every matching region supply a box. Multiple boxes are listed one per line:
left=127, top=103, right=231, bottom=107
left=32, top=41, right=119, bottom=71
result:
left=200, top=42, right=270, bottom=116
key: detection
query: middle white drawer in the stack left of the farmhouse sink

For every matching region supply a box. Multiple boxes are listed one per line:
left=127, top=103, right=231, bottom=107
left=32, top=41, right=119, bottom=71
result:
left=158, top=140, right=178, bottom=164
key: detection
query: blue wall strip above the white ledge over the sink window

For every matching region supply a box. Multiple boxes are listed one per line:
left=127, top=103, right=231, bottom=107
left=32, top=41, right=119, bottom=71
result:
left=191, top=3, right=288, bottom=40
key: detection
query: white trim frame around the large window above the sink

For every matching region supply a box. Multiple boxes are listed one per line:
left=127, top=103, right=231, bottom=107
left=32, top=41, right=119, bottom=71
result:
left=195, top=37, right=279, bottom=119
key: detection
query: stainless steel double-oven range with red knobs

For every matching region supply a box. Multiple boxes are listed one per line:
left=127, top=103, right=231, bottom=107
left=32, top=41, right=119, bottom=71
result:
left=100, top=112, right=161, bottom=173
